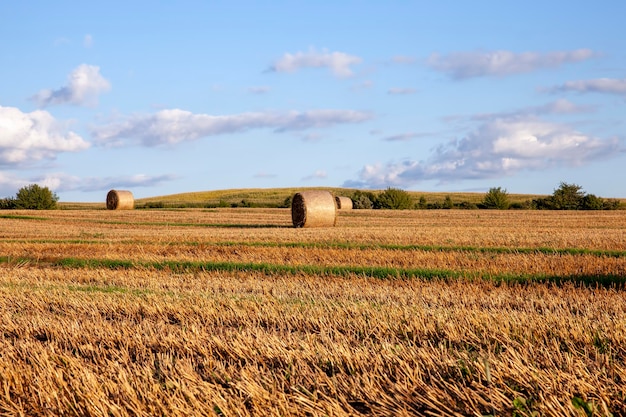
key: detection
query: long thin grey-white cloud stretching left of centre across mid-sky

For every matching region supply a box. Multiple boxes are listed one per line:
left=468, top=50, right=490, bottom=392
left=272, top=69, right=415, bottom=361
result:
left=92, top=109, right=373, bottom=146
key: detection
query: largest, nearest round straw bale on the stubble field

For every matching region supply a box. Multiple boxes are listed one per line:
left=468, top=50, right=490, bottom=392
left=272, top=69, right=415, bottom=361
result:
left=291, top=190, right=337, bottom=227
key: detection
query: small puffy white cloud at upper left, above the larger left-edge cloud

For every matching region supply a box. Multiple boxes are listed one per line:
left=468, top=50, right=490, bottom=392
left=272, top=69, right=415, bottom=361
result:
left=32, top=64, right=111, bottom=107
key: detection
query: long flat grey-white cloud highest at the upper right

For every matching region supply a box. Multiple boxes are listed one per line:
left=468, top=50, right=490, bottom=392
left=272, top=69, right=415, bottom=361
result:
left=427, top=49, right=596, bottom=79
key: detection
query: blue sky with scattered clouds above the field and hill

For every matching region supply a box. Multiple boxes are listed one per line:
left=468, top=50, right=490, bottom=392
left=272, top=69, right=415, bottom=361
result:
left=0, top=0, right=626, bottom=202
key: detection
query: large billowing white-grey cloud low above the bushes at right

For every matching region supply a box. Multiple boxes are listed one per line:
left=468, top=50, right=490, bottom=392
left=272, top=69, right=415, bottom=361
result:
left=345, top=116, right=622, bottom=188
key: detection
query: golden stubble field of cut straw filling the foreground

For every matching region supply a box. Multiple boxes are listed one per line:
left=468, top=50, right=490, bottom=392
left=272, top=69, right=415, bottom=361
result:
left=0, top=208, right=626, bottom=417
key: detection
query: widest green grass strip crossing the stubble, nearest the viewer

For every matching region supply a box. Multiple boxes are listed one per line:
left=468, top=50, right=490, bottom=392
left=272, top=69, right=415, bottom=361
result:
left=0, top=257, right=626, bottom=288
